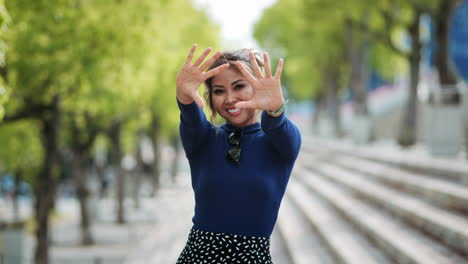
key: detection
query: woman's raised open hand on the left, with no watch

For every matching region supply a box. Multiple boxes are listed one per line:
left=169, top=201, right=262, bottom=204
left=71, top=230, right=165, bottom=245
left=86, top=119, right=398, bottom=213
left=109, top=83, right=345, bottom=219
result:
left=176, top=44, right=229, bottom=107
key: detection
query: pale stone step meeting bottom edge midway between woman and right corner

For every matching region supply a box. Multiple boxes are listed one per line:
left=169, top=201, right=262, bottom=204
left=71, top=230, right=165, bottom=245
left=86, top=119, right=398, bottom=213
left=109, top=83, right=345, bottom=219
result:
left=288, top=180, right=392, bottom=264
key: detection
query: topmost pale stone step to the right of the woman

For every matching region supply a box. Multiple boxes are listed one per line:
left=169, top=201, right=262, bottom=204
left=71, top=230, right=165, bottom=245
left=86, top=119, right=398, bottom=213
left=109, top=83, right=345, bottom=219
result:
left=301, top=136, right=468, bottom=185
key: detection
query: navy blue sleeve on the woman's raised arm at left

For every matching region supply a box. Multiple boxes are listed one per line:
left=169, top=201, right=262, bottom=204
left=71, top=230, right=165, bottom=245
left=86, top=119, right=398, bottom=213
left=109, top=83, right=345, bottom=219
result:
left=177, top=100, right=212, bottom=157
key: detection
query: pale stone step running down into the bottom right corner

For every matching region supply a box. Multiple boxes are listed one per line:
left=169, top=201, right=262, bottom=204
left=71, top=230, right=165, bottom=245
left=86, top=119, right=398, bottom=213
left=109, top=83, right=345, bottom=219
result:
left=294, top=164, right=467, bottom=264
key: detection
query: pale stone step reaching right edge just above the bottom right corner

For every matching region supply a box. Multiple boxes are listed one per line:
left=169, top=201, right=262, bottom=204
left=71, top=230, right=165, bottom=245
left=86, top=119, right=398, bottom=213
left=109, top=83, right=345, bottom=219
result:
left=298, top=161, right=468, bottom=255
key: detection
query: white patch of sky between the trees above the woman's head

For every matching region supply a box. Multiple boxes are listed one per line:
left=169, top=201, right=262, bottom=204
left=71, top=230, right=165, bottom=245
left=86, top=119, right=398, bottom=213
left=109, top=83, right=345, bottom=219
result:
left=192, top=0, right=277, bottom=48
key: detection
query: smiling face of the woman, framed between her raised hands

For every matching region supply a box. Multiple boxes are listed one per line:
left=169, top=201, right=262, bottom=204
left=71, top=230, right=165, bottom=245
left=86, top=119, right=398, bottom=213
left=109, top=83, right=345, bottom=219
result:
left=211, top=66, right=257, bottom=127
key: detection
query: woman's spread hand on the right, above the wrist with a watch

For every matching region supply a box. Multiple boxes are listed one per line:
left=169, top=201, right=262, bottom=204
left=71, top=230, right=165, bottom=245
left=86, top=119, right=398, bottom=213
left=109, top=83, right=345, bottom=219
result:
left=235, top=51, right=283, bottom=111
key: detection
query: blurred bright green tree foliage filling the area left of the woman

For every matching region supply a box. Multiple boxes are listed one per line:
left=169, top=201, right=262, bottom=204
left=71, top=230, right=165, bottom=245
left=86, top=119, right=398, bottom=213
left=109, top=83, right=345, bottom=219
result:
left=0, top=0, right=220, bottom=177
